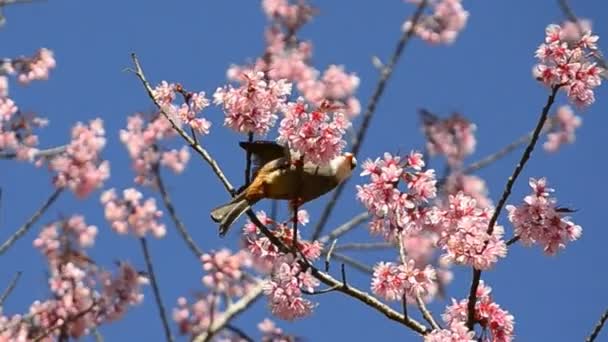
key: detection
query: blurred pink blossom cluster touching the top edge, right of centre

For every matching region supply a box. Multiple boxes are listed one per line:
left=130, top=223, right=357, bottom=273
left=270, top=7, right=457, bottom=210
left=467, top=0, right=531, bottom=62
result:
left=403, top=0, right=469, bottom=44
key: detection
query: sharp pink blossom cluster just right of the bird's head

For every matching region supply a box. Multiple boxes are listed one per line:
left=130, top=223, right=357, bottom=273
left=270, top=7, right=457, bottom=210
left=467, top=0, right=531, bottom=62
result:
left=357, top=152, right=437, bottom=240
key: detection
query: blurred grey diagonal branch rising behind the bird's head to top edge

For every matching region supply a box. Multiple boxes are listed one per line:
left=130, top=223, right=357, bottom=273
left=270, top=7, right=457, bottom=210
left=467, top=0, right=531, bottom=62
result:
left=312, top=0, right=428, bottom=240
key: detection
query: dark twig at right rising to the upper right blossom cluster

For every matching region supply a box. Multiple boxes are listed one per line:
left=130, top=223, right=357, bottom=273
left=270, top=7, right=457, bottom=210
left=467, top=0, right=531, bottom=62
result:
left=467, top=86, right=560, bottom=330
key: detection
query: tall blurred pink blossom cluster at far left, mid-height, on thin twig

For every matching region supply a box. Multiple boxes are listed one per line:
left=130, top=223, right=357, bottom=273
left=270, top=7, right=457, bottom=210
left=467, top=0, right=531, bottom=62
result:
left=49, top=119, right=110, bottom=198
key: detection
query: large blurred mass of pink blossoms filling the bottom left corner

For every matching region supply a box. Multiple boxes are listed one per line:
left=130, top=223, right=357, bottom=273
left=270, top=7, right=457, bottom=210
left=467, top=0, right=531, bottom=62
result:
left=0, top=216, right=147, bottom=341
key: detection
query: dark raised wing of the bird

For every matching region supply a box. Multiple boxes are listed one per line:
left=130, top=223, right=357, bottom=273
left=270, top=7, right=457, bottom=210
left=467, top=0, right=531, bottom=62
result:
left=239, top=141, right=290, bottom=177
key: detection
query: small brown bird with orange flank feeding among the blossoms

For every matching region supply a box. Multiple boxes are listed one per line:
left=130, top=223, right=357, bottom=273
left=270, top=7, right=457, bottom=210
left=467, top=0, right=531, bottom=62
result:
left=211, top=141, right=357, bottom=235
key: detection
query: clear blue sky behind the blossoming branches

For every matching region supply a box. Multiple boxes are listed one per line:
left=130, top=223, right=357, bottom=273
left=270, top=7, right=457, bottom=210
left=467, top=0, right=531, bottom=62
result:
left=0, top=0, right=608, bottom=341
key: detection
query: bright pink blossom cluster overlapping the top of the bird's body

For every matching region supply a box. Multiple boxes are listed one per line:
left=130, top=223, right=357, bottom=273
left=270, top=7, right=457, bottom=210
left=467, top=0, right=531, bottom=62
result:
left=278, top=98, right=351, bottom=164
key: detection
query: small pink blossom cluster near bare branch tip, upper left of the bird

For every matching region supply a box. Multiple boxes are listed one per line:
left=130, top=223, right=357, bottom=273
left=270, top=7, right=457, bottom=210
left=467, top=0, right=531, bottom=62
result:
left=152, top=81, right=211, bottom=135
